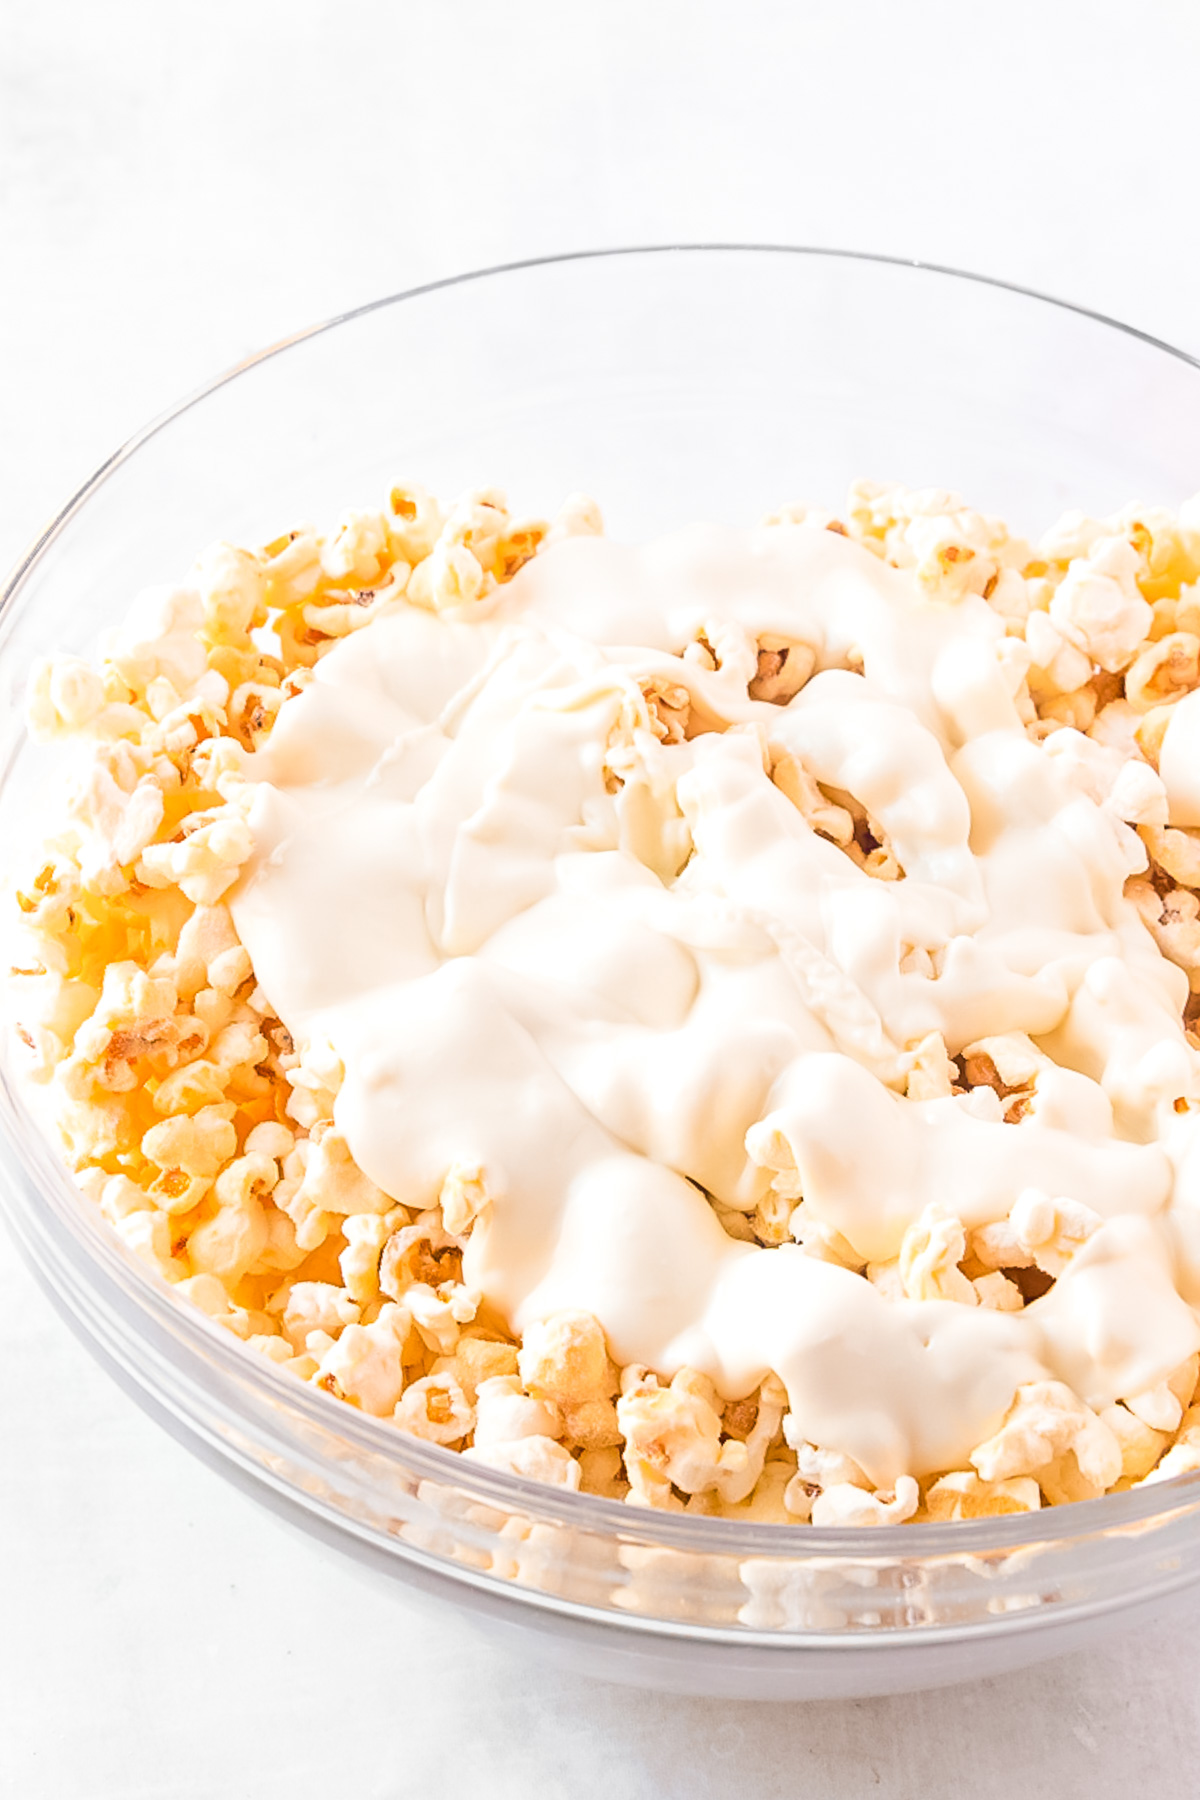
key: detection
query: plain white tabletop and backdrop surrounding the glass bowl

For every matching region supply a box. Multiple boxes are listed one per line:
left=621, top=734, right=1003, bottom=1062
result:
left=0, top=0, right=1200, bottom=1800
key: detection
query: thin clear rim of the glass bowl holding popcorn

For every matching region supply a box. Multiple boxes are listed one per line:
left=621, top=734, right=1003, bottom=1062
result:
left=0, top=241, right=1200, bottom=1576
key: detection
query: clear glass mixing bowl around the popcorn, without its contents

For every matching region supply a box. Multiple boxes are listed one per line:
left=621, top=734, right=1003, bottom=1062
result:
left=0, top=247, right=1200, bottom=1697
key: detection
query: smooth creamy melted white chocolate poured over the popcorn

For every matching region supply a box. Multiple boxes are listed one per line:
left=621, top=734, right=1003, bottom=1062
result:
left=232, top=527, right=1200, bottom=1481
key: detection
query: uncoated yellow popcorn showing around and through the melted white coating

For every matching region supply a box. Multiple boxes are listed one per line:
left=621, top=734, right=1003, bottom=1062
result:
left=11, top=482, right=1200, bottom=1525
